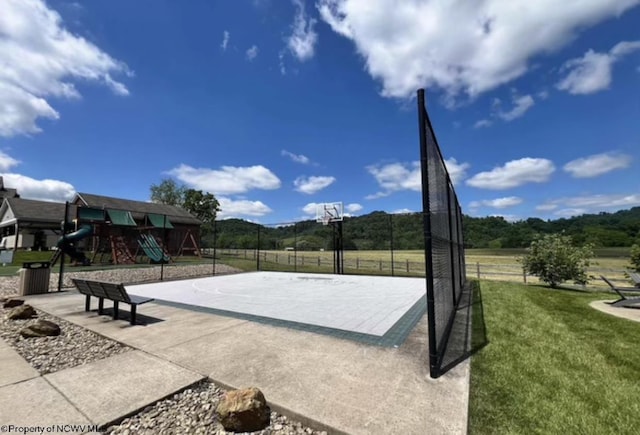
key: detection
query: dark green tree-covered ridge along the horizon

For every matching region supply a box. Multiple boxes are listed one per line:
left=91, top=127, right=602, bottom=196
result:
left=217, top=207, right=640, bottom=250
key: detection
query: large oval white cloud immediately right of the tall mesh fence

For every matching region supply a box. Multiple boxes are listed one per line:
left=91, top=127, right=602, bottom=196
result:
left=467, top=157, right=555, bottom=190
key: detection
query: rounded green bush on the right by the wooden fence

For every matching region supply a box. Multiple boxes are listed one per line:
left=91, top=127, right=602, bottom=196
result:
left=522, top=234, right=593, bottom=288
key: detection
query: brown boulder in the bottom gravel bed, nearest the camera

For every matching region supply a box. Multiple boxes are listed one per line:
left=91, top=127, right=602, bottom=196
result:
left=216, top=387, right=271, bottom=432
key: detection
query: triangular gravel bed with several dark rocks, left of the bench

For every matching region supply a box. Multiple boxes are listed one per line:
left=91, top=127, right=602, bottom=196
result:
left=0, top=305, right=131, bottom=375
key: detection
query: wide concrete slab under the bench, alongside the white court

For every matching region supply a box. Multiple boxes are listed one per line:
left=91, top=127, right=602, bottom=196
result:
left=11, top=284, right=469, bottom=434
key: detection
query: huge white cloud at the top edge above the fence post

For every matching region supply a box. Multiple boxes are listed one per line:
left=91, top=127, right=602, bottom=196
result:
left=317, top=0, right=640, bottom=99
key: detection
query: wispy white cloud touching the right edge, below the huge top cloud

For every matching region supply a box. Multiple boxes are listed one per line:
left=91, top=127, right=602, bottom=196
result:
left=556, top=41, right=640, bottom=95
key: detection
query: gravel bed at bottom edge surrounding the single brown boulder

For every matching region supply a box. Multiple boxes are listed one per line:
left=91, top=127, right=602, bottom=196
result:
left=106, top=381, right=326, bottom=435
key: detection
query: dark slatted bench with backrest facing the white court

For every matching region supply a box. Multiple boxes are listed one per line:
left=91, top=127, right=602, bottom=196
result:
left=72, top=278, right=153, bottom=325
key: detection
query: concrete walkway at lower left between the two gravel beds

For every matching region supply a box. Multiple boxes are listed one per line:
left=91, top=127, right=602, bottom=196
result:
left=0, top=340, right=203, bottom=433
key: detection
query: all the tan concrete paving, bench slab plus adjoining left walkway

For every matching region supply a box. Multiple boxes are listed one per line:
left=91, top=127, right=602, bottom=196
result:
left=0, top=292, right=469, bottom=434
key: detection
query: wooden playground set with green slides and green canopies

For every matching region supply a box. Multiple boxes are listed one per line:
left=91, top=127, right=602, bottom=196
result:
left=51, top=206, right=201, bottom=265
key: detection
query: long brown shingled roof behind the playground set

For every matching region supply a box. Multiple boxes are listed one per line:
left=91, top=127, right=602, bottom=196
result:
left=73, top=192, right=202, bottom=225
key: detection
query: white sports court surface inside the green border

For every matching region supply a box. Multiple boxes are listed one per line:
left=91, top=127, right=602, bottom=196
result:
left=127, top=272, right=426, bottom=336
